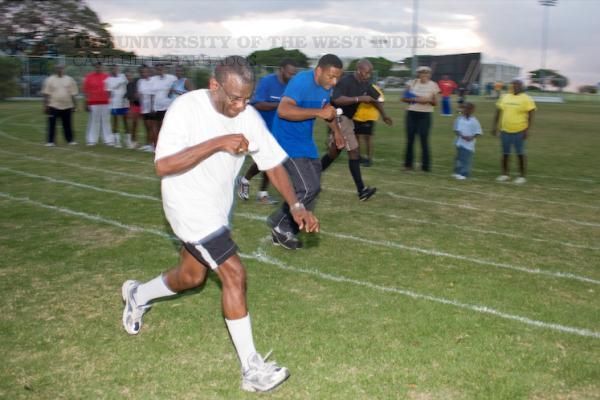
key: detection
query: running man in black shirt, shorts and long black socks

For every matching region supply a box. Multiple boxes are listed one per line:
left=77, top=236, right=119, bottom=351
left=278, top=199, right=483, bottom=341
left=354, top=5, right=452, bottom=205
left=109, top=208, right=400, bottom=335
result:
left=321, top=59, right=392, bottom=201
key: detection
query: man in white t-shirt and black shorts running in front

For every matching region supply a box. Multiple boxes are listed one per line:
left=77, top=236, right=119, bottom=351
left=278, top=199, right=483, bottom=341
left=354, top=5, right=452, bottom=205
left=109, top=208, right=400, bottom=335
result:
left=122, top=56, right=319, bottom=391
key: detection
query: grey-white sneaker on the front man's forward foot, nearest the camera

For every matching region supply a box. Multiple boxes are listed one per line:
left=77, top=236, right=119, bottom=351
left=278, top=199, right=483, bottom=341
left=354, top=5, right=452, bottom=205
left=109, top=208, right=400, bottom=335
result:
left=242, top=352, right=290, bottom=392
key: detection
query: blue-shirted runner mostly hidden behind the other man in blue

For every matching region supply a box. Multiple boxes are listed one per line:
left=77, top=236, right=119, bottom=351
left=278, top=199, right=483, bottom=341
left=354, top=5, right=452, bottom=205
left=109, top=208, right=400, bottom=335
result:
left=237, top=59, right=297, bottom=204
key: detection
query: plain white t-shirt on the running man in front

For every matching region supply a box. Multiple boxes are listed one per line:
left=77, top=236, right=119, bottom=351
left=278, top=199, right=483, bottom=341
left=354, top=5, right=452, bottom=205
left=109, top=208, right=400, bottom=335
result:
left=155, top=89, right=287, bottom=242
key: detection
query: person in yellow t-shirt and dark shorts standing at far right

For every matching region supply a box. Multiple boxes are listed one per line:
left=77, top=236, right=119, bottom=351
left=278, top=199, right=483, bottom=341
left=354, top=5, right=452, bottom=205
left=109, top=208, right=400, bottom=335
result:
left=492, top=79, right=535, bottom=184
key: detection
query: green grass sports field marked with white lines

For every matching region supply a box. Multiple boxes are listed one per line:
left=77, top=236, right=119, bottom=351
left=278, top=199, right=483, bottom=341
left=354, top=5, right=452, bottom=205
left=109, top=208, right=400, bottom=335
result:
left=0, top=100, right=600, bottom=400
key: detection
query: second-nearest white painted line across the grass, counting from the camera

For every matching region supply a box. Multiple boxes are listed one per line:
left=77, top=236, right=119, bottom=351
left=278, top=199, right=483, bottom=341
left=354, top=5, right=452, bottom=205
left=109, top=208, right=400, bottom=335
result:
left=0, top=167, right=600, bottom=284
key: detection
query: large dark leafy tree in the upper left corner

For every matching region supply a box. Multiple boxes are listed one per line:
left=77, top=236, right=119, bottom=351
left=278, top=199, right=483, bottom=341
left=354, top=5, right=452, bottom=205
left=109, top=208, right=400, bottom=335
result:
left=0, top=0, right=131, bottom=56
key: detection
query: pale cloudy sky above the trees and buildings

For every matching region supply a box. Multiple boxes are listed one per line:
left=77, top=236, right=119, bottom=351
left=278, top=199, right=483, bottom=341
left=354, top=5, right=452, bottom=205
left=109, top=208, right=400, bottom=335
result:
left=87, top=0, right=600, bottom=88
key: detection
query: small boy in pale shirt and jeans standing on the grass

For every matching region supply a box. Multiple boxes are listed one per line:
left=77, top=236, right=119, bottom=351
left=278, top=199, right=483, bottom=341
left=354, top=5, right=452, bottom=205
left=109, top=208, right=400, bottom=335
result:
left=452, top=102, right=482, bottom=180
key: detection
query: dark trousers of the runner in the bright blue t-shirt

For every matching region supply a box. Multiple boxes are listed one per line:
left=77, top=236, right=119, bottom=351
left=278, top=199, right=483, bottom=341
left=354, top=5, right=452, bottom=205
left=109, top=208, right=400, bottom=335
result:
left=268, top=158, right=321, bottom=233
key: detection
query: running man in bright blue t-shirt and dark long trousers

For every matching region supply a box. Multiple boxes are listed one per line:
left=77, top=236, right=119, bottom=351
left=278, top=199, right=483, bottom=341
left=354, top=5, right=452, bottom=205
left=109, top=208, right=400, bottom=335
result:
left=268, top=54, right=345, bottom=250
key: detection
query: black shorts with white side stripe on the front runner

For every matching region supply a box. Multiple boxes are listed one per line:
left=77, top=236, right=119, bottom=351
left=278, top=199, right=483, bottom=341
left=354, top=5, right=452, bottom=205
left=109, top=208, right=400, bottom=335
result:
left=183, top=226, right=238, bottom=269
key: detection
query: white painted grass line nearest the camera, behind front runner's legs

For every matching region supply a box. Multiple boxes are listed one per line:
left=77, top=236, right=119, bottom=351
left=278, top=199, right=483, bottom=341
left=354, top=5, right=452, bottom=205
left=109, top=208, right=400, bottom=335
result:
left=0, top=192, right=600, bottom=339
